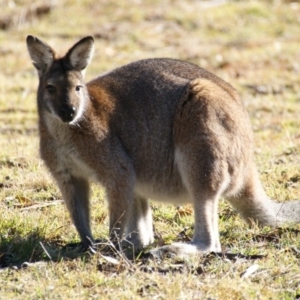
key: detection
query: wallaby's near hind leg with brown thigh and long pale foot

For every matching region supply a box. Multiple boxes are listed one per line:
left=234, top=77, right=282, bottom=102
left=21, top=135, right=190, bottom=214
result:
left=149, top=78, right=232, bottom=256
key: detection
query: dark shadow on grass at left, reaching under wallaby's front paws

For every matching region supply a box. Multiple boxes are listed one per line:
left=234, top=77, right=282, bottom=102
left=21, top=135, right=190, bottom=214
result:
left=0, top=231, right=149, bottom=269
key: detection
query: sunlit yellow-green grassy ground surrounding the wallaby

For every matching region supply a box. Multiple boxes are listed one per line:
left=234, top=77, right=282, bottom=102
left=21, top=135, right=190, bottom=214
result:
left=0, top=0, right=300, bottom=299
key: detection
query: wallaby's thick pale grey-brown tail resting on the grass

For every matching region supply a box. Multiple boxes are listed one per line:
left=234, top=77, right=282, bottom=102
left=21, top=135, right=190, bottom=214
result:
left=228, top=164, right=300, bottom=227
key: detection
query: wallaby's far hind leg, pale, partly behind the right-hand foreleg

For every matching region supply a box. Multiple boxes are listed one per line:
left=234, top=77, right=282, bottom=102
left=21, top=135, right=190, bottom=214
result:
left=126, top=196, right=154, bottom=250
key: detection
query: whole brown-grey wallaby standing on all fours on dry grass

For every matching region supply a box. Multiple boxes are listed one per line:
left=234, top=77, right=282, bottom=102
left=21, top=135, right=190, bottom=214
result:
left=27, top=35, right=300, bottom=255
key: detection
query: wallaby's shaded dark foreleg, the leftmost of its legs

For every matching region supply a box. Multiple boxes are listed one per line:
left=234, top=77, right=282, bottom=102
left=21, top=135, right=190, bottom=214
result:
left=56, top=175, right=94, bottom=248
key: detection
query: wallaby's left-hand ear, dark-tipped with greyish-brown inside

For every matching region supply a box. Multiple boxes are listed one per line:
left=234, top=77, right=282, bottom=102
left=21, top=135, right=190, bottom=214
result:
left=26, top=35, right=55, bottom=76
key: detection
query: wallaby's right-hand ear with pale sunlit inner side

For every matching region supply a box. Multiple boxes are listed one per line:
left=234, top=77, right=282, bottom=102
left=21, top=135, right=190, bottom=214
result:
left=65, top=36, right=94, bottom=71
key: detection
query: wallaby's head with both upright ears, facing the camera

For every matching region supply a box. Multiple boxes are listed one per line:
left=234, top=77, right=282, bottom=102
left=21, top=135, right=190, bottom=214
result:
left=27, top=35, right=94, bottom=123
